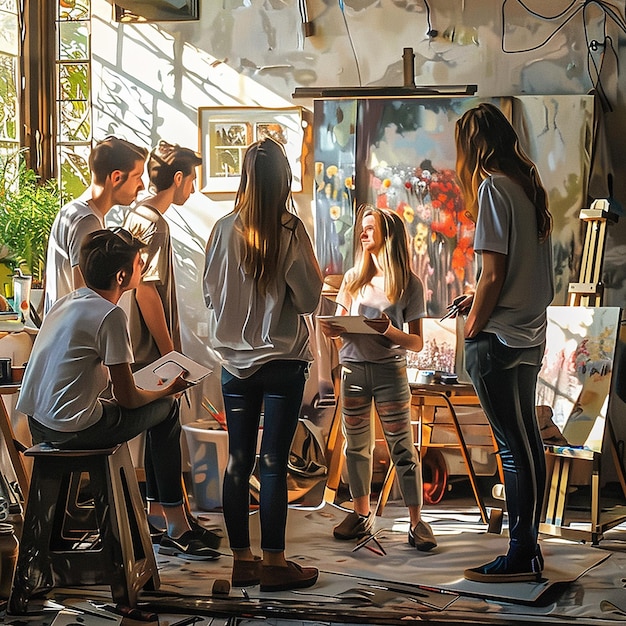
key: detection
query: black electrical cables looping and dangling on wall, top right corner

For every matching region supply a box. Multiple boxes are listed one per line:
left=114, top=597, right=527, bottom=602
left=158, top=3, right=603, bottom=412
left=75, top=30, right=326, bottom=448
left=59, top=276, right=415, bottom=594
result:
left=501, top=0, right=626, bottom=111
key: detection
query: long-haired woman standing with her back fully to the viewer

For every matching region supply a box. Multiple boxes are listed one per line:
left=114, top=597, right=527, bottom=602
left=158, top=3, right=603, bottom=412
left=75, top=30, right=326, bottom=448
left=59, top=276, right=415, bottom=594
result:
left=204, top=139, right=322, bottom=591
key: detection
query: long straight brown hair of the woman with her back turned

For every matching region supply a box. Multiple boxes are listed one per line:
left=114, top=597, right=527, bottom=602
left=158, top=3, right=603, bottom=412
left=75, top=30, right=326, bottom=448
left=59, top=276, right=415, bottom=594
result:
left=235, top=138, right=293, bottom=294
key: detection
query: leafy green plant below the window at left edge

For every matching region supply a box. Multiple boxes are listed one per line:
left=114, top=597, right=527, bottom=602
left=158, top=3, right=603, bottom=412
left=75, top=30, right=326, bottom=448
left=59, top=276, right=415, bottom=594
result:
left=0, top=151, right=60, bottom=288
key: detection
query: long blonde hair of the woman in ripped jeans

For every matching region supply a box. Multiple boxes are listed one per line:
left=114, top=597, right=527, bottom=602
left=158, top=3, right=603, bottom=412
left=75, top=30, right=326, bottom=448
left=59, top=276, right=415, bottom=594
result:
left=346, top=204, right=411, bottom=304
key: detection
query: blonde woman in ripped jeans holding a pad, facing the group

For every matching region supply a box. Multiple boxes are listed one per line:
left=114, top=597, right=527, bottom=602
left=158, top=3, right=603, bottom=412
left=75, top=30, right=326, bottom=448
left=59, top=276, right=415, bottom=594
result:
left=320, top=206, right=437, bottom=551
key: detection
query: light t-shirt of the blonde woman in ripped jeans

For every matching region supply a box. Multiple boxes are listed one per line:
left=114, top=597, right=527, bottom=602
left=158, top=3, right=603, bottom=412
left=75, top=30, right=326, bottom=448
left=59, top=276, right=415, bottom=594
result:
left=337, top=268, right=426, bottom=363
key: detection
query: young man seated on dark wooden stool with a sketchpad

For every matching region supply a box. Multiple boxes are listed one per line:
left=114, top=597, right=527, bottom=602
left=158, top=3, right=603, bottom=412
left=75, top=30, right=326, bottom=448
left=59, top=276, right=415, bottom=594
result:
left=17, top=228, right=219, bottom=559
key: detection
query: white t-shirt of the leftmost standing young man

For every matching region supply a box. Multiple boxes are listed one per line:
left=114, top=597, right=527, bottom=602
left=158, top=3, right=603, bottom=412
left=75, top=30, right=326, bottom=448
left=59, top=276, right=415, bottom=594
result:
left=44, top=190, right=104, bottom=313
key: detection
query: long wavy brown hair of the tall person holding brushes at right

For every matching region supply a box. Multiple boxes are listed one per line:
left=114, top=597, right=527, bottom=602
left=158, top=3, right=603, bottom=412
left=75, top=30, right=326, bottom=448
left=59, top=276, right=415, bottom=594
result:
left=455, top=102, right=552, bottom=240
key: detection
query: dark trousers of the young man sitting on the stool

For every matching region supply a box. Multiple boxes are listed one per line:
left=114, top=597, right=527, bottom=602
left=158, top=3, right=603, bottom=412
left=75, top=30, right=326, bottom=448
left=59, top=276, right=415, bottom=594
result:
left=29, top=397, right=184, bottom=506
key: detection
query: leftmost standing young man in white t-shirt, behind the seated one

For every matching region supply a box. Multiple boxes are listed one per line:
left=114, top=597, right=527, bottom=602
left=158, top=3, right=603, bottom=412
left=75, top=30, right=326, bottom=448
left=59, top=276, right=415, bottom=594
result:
left=44, top=136, right=148, bottom=313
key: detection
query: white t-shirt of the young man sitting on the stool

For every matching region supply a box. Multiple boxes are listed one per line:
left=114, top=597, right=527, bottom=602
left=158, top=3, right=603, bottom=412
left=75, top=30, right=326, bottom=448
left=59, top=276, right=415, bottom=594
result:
left=17, top=287, right=133, bottom=432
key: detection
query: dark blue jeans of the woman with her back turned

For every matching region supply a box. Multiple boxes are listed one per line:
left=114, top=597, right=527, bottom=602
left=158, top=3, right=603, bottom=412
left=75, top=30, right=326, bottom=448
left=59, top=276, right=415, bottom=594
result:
left=222, top=360, right=308, bottom=552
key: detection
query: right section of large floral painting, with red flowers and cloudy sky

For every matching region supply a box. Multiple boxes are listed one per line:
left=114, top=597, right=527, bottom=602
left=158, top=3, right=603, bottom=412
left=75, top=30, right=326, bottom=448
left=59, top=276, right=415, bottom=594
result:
left=356, top=98, right=476, bottom=317
